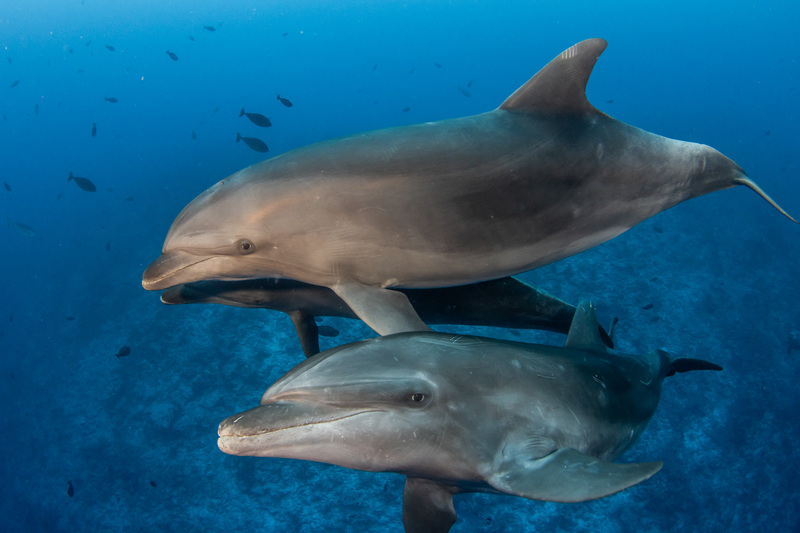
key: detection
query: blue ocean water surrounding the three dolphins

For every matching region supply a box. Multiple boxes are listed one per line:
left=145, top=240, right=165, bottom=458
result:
left=0, top=0, right=800, bottom=532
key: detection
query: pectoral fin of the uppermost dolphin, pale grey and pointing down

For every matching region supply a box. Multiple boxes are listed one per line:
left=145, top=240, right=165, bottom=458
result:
left=331, top=283, right=430, bottom=335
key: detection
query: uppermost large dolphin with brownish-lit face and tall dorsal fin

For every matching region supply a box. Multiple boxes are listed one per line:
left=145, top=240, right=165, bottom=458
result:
left=142, top=39, right=794, bottom=335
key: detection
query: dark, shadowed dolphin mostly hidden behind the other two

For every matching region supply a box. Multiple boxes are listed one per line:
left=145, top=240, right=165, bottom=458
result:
left=161, top=278, right=614, bottom=357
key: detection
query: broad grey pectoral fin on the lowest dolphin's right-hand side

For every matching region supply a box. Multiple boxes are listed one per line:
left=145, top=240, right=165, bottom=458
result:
left=488, top=448, right=663, bottom=503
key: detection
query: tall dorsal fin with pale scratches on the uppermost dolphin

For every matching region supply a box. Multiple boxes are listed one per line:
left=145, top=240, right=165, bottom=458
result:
left=500, top=39, right=608, bottom=113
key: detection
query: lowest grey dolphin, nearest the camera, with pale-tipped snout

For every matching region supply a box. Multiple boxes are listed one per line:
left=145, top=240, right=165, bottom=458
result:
left=218, top=302, right=721, bottom=532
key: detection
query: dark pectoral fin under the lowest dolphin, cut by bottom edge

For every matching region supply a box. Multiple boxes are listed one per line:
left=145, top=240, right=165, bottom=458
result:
left=403, top=477, right=456, bottom=533
